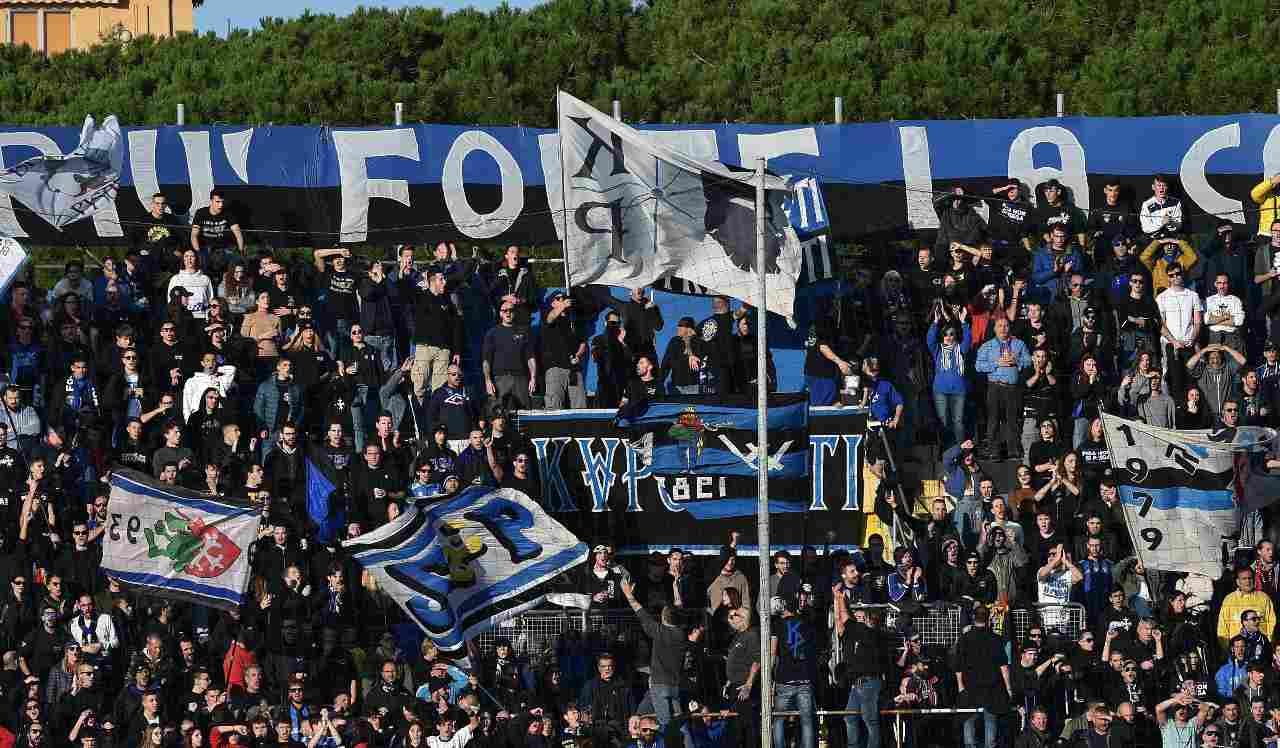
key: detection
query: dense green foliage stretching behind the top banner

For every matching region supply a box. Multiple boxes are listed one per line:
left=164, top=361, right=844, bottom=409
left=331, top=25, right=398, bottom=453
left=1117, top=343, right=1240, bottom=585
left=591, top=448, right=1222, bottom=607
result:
left=0, top=0, right=1280, bottom=127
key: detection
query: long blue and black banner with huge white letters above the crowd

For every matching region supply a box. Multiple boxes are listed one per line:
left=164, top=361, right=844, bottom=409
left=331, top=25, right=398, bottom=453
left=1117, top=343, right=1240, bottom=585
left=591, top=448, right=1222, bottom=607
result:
left=0, top=112, right=1280, bottom=248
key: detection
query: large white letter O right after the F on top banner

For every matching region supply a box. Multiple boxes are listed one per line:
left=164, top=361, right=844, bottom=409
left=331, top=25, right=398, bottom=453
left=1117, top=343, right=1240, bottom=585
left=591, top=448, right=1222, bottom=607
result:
left=440, top=129, right=525, bottom=240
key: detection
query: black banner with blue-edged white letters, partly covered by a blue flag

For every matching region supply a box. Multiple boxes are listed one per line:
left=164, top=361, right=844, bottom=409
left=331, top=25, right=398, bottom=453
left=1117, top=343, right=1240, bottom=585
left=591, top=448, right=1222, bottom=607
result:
left=520, top=407, right=867, bottom=553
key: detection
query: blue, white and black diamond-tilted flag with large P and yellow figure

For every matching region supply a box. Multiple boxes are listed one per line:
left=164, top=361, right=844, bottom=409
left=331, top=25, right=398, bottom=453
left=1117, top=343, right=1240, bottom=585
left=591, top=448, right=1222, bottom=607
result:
left=343, top=485, right=588, bottom=651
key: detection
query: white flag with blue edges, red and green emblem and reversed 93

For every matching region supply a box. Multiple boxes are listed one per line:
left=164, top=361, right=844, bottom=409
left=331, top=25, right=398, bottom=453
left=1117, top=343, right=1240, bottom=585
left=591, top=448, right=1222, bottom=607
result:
left=102, top=469, right=262, bottom=610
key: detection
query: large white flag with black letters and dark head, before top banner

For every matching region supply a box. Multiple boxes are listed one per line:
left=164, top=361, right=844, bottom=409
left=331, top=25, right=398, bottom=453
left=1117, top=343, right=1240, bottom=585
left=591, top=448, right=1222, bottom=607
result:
left=544, top=91, right=801, bottom=318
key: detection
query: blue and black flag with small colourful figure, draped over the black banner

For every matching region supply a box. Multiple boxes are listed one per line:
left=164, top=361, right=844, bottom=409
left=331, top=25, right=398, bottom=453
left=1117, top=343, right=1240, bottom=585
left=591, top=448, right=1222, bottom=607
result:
left=617, top=393, right=810, bottom=519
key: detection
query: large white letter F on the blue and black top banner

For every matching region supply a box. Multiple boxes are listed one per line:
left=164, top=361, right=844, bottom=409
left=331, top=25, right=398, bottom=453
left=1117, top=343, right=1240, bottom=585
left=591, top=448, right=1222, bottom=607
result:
left=333, top=129, right=420, bottom=242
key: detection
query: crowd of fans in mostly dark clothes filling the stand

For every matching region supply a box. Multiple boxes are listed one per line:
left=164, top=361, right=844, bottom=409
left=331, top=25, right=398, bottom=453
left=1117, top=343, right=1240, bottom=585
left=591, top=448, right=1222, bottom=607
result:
left=0, top=167, right=1280, bottom=748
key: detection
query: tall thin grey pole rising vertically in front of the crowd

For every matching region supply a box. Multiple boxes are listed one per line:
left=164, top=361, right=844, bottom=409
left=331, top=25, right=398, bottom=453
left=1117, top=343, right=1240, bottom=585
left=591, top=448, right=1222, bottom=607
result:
left=755, top=159, right=773, bottom=748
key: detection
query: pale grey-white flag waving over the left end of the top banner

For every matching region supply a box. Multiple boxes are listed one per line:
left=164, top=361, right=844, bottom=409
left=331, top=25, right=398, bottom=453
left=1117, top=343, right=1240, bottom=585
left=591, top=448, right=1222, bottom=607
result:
left=0, top=115, right=124, bottom=229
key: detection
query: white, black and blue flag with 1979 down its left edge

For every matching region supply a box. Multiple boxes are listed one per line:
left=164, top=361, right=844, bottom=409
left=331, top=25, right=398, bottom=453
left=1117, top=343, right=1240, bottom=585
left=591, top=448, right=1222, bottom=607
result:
left=1102, top=414, right=1275, bottom=579
